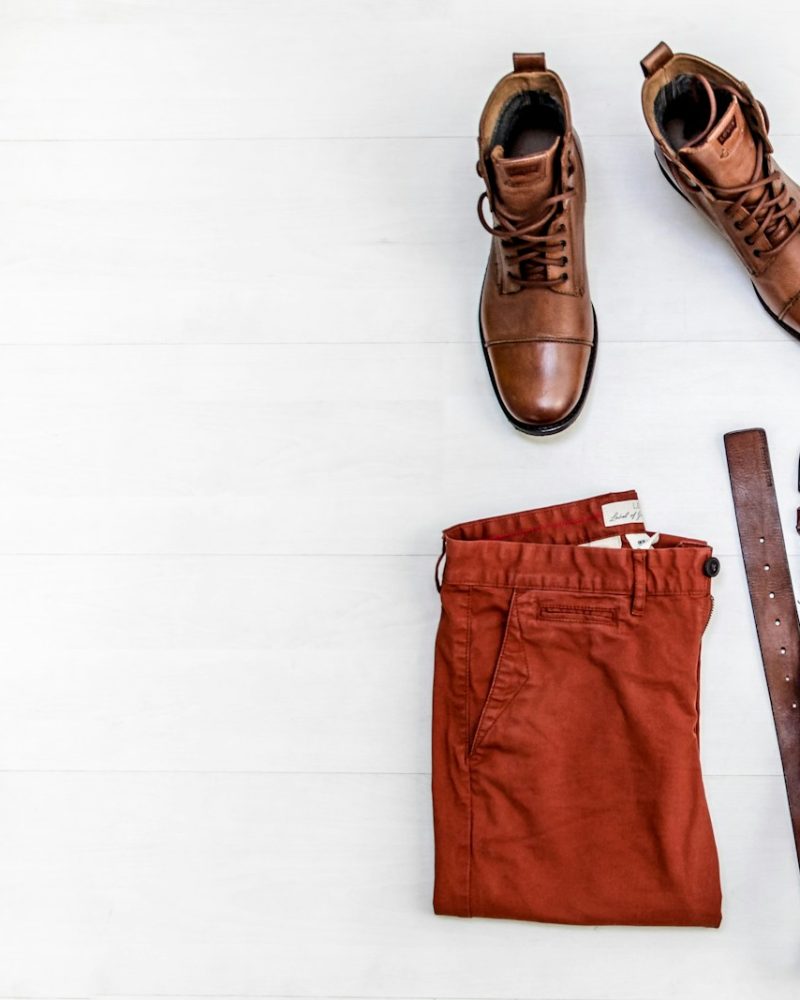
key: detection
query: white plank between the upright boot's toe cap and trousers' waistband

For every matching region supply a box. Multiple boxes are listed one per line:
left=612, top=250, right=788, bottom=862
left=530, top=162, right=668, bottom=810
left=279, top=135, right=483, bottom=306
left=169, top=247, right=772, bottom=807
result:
left=0, top=342, right=800, bottom=555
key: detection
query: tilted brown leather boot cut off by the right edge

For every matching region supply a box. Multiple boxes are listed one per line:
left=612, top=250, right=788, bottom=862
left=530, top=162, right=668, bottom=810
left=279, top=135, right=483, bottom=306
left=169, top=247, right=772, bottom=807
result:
left=641, top=42, right=800, bottom=337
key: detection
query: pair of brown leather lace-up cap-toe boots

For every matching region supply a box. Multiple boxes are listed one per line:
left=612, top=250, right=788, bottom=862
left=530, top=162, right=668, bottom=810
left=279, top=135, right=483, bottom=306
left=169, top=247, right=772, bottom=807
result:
left=478, top=42, right=800, bottom=435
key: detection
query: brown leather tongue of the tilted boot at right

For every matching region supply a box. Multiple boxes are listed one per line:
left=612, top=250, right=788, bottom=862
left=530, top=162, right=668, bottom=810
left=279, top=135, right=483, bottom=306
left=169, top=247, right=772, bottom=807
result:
left=679, top=88, right=763, bottom=202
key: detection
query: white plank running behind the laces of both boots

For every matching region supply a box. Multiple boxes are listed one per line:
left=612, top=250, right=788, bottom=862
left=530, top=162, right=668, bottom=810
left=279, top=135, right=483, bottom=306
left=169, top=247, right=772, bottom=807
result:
left=0, top=136, right=800, bottom=344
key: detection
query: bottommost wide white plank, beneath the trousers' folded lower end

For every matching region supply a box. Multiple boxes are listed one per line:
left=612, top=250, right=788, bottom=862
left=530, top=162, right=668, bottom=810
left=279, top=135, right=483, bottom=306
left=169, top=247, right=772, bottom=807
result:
left=0, top=775, right=800, bottom=1000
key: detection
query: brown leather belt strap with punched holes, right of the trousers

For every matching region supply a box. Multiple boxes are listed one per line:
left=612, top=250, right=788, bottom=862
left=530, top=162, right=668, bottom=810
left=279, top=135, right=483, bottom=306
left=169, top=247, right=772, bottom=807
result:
left=725, top=428, right=800, bottom=861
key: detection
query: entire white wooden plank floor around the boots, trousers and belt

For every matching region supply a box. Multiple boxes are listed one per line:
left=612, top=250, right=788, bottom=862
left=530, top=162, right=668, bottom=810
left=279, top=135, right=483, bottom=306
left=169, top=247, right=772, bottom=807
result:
left=0, top=0, right=800, bottom=1000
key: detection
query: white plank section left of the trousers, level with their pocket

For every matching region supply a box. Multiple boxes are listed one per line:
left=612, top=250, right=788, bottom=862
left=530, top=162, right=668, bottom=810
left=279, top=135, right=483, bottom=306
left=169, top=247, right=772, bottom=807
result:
left=0, top=557, right=438, bottom=771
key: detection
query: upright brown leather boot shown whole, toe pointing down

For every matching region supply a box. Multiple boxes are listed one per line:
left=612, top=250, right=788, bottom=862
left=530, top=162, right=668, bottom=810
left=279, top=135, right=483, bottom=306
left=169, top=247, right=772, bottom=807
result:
left=478, top=53, right=597, bottom=434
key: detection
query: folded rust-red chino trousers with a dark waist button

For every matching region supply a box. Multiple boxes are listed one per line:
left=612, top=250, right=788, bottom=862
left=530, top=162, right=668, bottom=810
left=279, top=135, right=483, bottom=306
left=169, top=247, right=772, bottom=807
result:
left=433, top=490, right=721, bottom=927
